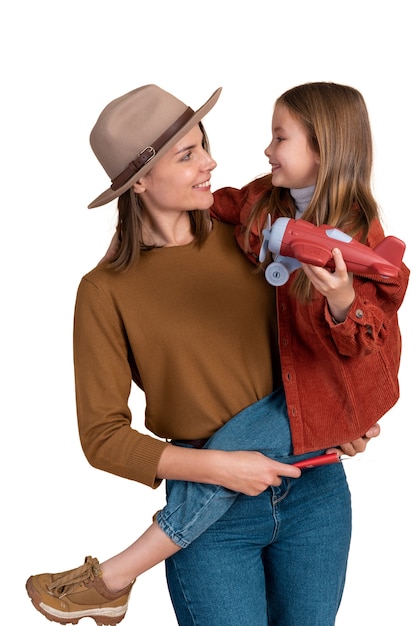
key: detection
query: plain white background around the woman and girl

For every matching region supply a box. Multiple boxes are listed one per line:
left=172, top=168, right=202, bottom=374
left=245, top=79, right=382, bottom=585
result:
left=0, top=0, right=417, bottom=626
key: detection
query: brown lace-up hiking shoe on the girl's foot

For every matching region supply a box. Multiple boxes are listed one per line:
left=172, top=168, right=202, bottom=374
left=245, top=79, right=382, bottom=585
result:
left=26, top=556, right=135, bottom=626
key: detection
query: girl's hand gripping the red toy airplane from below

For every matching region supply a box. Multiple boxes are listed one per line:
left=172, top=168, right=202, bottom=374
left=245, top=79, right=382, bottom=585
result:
left=302, top=248, right=355, bottom=322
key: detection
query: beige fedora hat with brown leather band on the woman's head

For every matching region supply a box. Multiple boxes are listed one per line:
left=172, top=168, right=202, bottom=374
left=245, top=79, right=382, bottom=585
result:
left=88, top=85, right=221, bottom=209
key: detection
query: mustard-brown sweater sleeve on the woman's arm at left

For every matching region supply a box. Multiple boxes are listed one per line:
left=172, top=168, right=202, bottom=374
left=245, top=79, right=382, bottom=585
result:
left=74, top=277, right=169, bottom=488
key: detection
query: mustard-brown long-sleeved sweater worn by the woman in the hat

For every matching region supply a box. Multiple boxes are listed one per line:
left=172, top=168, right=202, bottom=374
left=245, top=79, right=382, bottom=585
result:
left=74, top=221, right=280, bottom=487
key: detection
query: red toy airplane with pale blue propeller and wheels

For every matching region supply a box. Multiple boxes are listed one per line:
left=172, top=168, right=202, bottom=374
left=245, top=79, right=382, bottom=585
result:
left=259, top=215, right=405, bottom=287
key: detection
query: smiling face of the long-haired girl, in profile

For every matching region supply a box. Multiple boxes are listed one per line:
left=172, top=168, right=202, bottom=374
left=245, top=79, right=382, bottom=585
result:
left=265, top=103, right=320, bottom=189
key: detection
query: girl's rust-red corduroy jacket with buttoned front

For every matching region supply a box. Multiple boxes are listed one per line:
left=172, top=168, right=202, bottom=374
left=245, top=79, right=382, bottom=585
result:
left=212, top=178, right=409, bottom=454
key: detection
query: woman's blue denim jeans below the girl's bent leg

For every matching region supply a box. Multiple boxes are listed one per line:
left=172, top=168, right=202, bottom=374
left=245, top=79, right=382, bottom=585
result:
left=166, top=463, right=351, bottom=626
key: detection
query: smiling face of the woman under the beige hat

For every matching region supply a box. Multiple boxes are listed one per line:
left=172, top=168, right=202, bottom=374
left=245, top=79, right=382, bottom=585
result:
left=133, top=125, right=217, bottom=216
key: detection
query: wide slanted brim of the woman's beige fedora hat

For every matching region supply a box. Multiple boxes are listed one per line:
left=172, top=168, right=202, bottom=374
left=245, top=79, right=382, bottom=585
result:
left=88, top=87, right=222, bottom=209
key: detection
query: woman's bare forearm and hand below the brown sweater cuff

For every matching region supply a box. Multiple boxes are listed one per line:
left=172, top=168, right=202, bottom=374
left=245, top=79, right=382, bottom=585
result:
left=158, top=445, right=301, bottom=496
